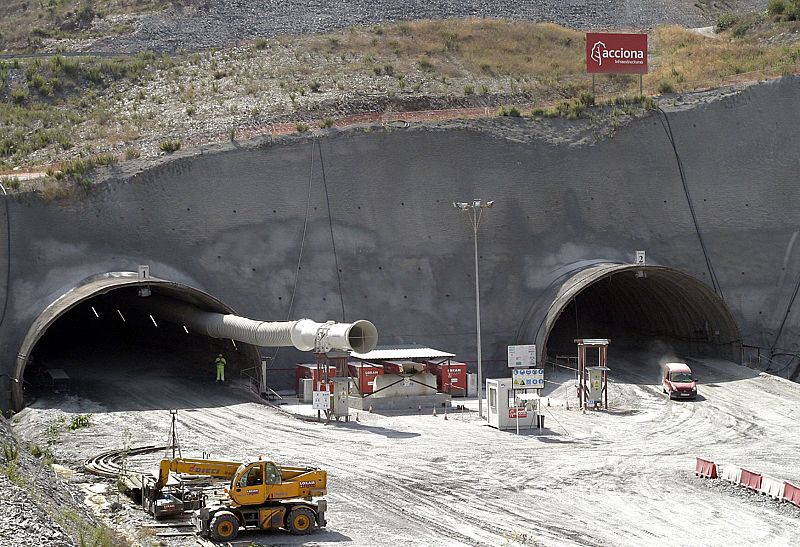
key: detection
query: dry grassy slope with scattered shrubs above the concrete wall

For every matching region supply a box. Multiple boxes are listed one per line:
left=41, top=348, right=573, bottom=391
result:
left=0, top=16, right=800, bottom=191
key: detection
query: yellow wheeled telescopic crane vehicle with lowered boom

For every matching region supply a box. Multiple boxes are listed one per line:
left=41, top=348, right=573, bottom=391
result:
left=142, top=458, right=328, bottom=541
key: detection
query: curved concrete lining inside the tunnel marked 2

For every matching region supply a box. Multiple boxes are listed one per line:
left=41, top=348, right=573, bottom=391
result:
left=529, top=263, right=742, bottom=363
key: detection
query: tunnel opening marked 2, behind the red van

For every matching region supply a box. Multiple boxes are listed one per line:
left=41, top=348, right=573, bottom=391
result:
left=537, top=264, right=742, bottom=362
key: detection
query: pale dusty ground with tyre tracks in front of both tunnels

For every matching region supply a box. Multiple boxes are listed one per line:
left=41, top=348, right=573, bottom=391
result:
left=16, top=352, right=800, bottom=547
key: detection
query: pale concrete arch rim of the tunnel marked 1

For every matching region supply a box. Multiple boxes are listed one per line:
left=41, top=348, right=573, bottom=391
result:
left=12, top=272, right=260, bottom=410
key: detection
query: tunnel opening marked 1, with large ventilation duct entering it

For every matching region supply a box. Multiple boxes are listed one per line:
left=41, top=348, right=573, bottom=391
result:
left=14, top=275, right=260, bottom=408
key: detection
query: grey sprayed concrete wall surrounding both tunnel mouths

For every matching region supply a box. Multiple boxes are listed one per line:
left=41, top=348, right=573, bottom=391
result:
left=0, top=78, right=800, bottom=406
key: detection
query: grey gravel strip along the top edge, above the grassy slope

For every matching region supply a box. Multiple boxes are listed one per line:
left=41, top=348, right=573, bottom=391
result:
left=51, top=0, right=766, bottom=53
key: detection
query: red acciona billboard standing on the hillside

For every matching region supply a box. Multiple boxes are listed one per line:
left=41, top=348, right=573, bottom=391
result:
left=586, top=32, right=647, bottom=74
